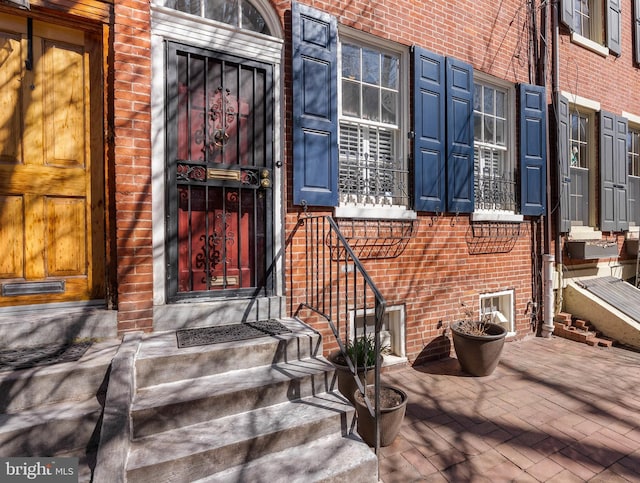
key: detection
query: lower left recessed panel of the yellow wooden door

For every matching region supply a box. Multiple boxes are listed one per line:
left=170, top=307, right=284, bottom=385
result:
left=0, top=196, right=24, bottom=278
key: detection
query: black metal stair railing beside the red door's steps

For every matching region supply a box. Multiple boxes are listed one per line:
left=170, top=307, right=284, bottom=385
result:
left=291, top=216, right=386, bottom=462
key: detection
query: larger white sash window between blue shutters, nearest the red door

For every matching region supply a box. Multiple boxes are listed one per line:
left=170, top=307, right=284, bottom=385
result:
left=338, top=40, right=408, bottom=207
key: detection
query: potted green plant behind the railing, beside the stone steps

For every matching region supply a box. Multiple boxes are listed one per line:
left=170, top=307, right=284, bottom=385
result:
left=329, top=334, right=382, bottom=404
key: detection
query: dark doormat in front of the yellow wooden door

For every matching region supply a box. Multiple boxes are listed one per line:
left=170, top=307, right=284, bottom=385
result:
left=0, top=342, right=91, bottom=372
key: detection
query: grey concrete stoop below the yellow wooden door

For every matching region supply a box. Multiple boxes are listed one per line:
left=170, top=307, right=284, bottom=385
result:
left=0, top=340, right=120, bottom=481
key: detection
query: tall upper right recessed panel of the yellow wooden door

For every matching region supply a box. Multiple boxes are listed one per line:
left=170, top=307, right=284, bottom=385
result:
left=41, top=40, right=87, bottom=167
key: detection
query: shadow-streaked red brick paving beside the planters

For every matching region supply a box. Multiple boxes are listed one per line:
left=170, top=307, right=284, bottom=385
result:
left=380, top=337, right=640, bottom=483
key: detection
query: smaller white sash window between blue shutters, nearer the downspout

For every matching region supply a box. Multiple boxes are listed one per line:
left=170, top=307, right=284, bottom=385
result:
left=473, top=82, right=516, bottom=212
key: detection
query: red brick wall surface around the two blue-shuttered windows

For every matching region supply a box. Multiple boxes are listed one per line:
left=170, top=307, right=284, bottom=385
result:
left=284, top=0, right=541, bottom=363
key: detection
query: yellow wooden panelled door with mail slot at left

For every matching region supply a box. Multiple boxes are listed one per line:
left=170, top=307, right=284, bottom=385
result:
left=0, top=14, right=105, bottom=307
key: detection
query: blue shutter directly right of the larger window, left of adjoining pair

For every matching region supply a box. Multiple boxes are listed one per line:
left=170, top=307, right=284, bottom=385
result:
left=413, top=47, right=446, bottom=213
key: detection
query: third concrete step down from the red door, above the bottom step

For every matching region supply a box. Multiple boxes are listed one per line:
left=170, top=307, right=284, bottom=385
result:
left=127, top=393, right=354, bottom=483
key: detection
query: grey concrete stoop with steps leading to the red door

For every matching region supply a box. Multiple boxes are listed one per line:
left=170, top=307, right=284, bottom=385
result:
left=94, top=319, right=378, bottom=483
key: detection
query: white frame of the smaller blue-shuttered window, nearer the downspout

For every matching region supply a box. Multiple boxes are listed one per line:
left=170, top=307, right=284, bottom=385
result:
left=473, top=72, right=521, bottom=217
